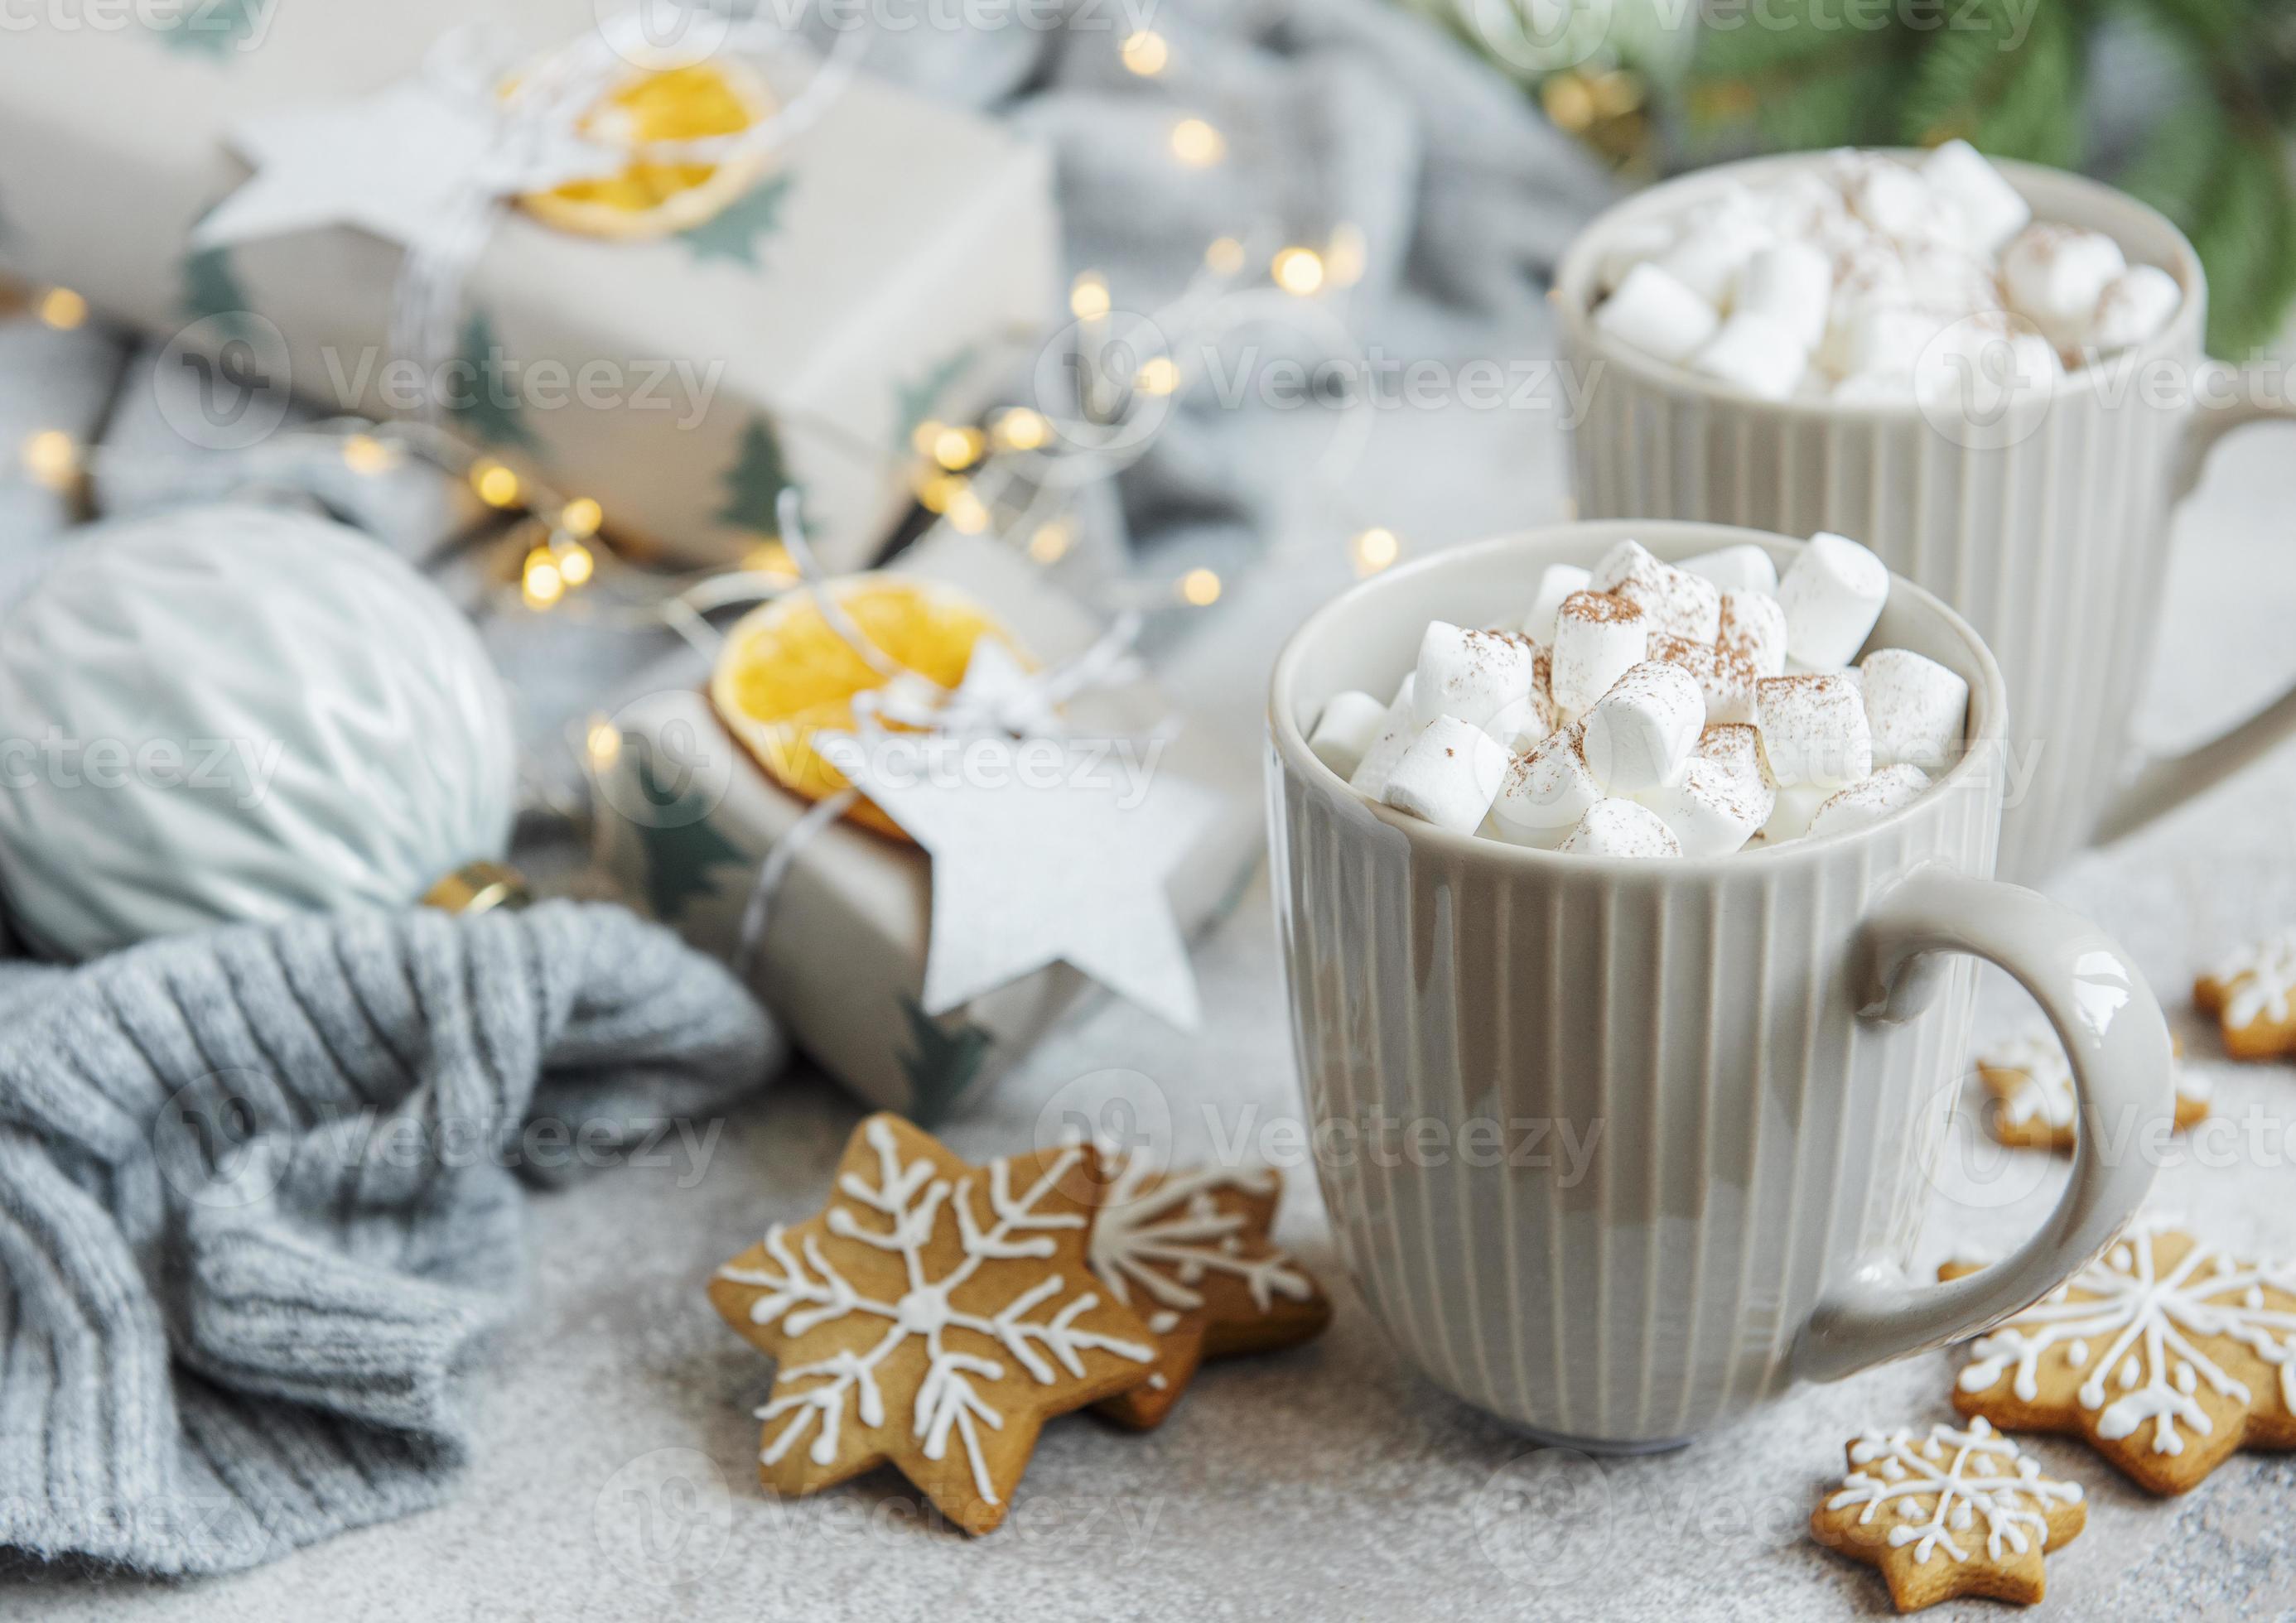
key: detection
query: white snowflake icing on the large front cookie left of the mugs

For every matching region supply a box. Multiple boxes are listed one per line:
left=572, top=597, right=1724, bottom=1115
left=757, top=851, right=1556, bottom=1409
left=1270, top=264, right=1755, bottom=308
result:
left=719, top=1120, right=1155, bottom=1504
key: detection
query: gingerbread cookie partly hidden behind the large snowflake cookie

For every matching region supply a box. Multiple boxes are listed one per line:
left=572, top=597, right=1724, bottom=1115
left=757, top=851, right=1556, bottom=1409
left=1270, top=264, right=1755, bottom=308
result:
left=1093, top=1154, right=1332, bottom=1430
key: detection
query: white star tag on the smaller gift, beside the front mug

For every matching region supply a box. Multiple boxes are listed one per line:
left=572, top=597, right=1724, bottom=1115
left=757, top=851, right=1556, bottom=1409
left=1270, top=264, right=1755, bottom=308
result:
left=815, top=732, right=1217, bottom=1031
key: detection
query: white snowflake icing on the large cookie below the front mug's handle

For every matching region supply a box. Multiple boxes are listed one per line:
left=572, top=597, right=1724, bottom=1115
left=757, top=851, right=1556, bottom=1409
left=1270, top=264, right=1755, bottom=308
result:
left=1961, top=1219, right=2296, bottom=1453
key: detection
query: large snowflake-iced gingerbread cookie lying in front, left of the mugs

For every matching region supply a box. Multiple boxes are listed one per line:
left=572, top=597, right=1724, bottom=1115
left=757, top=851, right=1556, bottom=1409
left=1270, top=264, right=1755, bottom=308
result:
left=710, top=1115, right=1157, bottom=1534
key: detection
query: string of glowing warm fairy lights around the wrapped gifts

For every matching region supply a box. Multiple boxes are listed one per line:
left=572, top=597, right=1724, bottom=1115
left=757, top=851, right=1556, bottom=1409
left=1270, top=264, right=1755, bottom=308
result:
left=4, top=30, right=1403, bottom=640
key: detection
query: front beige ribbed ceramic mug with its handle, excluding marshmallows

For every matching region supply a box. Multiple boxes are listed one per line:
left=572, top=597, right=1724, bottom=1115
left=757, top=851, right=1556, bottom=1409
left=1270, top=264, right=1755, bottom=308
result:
left=1267, top=523, right=2172, bottom=1448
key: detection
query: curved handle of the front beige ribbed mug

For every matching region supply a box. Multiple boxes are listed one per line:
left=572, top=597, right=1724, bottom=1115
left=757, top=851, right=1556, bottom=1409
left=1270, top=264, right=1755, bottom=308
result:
left=1793, top=868, right=2174, bottom=1380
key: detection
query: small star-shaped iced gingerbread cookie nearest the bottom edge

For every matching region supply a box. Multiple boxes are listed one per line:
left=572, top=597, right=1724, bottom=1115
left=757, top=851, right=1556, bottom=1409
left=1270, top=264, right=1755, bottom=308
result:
left=1809, top=1418, right=2087, bottom=1611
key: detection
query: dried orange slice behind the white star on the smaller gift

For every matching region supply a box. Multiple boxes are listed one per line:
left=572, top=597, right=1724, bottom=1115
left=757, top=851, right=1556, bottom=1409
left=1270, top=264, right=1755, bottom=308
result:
left=710, top=571, right=1033, bottom=840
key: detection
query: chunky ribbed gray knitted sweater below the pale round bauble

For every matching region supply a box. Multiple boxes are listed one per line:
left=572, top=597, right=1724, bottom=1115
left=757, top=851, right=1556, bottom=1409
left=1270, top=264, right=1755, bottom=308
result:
left=0, top=903, right=780, bottom=1572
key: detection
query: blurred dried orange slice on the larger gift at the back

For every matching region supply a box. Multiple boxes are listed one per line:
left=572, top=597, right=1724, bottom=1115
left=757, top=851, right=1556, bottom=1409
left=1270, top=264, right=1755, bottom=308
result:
left=519, top=60, right=774, bottom=238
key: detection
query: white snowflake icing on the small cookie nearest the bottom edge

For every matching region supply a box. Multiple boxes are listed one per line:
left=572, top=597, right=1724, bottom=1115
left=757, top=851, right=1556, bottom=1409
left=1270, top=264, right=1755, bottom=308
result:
left=1826, top=1418, right=2080, bottom=1566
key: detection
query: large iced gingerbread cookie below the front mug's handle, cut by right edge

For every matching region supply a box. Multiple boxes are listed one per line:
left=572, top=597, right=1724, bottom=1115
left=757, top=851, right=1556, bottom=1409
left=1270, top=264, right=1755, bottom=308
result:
left=1938, top=1219, right=2296, bottom=1495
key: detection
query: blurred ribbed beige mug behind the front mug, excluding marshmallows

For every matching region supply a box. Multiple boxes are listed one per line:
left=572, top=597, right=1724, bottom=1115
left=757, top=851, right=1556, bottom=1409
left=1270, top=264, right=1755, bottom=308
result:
left=1555, top=154, right=2296, bottom=879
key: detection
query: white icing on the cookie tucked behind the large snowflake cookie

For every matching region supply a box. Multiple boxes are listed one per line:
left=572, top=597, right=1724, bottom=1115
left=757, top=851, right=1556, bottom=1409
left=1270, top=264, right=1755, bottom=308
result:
left=1091, top=1154, right=1315, bottom=1334
